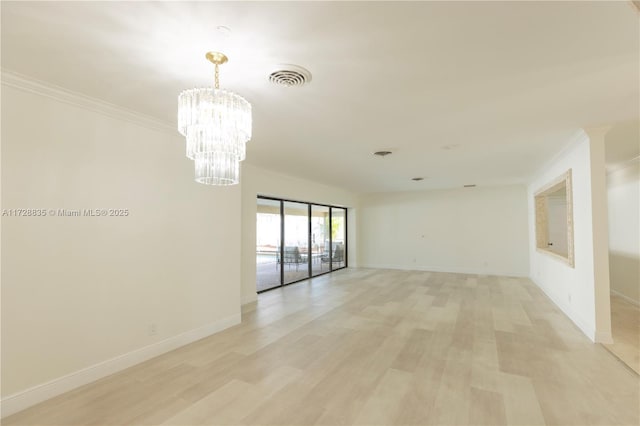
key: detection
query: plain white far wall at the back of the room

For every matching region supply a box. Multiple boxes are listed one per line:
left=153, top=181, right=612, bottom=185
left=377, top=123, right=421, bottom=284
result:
left=358, top=186, right=529, bottom=276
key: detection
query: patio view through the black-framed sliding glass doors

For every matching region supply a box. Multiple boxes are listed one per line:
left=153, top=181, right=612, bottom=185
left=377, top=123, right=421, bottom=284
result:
left=256, top=197, right=347, bottom=292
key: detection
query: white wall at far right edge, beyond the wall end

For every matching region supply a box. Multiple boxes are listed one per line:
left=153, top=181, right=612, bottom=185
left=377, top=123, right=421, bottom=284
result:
left=607, top=159, right=640, bottom=304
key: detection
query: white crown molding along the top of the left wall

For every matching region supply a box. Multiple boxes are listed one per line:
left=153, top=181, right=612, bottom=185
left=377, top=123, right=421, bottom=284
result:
left=1, top=69, right=177, bottom=133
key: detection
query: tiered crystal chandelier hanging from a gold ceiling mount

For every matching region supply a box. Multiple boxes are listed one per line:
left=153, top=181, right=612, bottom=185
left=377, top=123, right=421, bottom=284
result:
left=178, top=52, right=251, bottom=185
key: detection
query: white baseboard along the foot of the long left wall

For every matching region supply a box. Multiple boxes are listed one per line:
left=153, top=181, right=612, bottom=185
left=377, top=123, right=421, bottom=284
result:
left=0, top=313, right=241, bottom=418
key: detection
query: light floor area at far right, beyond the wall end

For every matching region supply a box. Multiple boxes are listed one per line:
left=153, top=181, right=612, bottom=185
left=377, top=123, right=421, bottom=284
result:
left=605, top=294, right=640, bottom=374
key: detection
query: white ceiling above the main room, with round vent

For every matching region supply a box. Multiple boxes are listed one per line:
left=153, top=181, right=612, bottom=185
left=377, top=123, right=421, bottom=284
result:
left=1, top=1, right=640, bottom=192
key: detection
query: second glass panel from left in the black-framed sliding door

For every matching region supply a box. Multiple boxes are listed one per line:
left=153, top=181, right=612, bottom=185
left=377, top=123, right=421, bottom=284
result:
left=282, top=201, right=310, bottom=284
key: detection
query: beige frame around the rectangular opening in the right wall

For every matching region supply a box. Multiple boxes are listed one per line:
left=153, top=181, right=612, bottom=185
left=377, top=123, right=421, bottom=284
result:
left=533, top=169, right=575, bottom=268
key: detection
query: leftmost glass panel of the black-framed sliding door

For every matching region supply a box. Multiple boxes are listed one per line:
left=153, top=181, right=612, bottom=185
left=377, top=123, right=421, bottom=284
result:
left=256, top=198, right=282, bottom=291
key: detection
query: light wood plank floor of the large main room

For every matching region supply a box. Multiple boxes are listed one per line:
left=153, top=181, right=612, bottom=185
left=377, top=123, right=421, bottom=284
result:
left=3, top=269, right=640, bottom=425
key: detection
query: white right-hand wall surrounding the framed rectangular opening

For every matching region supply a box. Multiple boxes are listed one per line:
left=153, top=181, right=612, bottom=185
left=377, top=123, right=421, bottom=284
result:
left=528, top=132, right=611, bottom=341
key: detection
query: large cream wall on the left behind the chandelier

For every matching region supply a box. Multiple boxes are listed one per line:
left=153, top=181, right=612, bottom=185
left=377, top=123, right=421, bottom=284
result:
left=2, top=76, right=241, bottom=415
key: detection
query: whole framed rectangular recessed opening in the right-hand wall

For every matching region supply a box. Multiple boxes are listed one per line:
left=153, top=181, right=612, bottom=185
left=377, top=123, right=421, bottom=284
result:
left=534, top=169, right=575, bottom=268
